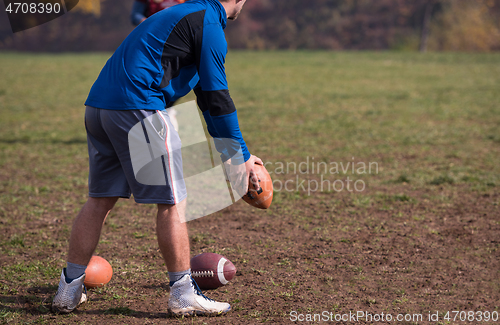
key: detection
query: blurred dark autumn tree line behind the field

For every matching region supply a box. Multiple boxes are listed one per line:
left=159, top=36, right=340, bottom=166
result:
left=0, top=0, right=500, bottom=52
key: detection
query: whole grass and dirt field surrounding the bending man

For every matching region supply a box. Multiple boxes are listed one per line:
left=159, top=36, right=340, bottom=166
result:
left=0, top=51, right=500, bottom=324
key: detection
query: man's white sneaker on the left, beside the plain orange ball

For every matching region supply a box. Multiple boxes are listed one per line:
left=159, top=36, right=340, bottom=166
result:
left=52, top=269, right=87, bottom=314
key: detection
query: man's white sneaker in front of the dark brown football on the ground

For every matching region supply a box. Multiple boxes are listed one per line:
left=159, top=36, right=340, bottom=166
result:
left=168, top=274, right=231, bottom=316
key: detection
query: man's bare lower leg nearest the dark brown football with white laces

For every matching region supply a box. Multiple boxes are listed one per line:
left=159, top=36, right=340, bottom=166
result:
left=156, top=200, right=190, bottom=272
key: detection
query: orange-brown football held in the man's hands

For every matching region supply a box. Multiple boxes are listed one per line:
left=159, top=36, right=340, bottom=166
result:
left=243, top=164, right=273, bottom=209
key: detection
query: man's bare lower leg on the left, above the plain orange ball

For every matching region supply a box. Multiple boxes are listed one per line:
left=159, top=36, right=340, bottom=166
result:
left=68, top=197, right=118, bottom=265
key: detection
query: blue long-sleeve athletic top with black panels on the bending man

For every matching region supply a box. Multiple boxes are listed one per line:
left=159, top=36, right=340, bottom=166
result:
left=85, top=0, right=250, bottom=161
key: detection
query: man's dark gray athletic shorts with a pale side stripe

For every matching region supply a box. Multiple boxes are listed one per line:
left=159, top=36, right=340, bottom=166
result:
left=85, top=106, right=187, bottom=204
